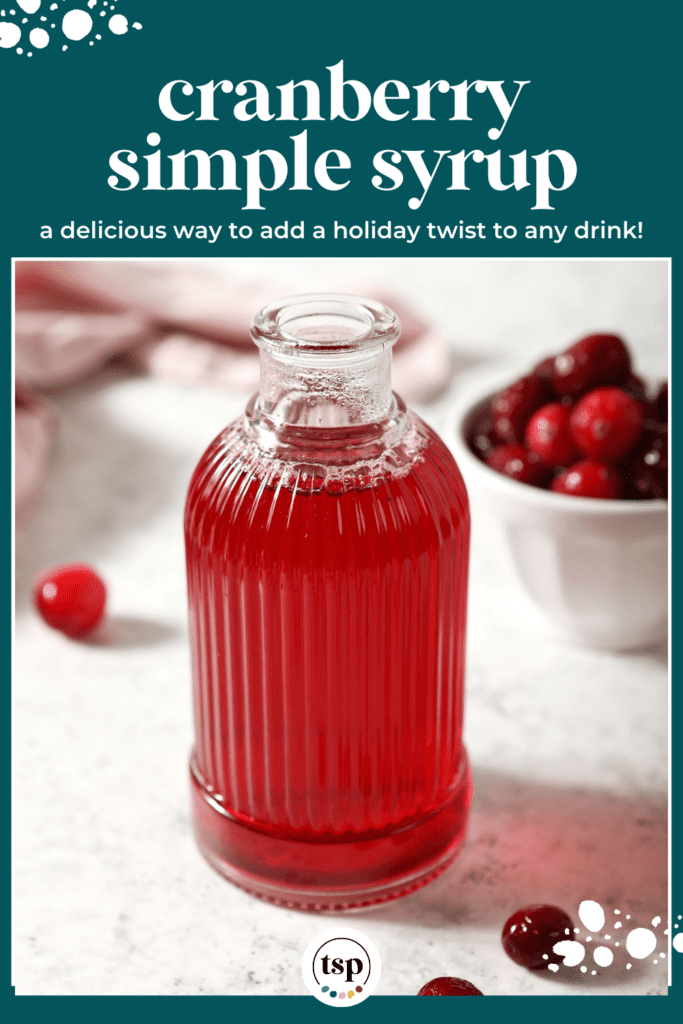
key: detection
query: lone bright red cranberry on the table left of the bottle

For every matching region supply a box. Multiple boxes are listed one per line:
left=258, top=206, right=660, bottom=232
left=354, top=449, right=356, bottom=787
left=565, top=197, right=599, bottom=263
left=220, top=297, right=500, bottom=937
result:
left=33, top=565, right=106, bottom=637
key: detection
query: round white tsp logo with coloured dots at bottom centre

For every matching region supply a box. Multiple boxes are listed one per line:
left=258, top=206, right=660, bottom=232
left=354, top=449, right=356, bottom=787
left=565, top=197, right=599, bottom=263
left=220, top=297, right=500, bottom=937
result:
left=301, top=926, right=382, bottom=1007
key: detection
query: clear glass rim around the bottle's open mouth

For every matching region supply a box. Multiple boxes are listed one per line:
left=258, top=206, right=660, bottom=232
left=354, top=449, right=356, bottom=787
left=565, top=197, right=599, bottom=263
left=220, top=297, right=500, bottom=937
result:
left=252, top=292, right=400, bottom=356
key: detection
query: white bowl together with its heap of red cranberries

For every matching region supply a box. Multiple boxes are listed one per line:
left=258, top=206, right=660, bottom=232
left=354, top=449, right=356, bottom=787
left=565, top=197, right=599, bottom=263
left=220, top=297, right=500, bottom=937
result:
left=452, top=334, right=669, bottom=649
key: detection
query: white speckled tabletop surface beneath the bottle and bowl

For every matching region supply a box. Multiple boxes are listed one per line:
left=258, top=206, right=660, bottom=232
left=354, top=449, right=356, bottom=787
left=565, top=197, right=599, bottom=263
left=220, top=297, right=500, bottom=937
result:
left=13, top=261, right=677, bottom=995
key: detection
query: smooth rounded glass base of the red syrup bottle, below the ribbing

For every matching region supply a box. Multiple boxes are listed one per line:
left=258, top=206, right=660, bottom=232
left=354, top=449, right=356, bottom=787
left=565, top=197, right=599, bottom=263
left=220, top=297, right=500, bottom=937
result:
left=190, top=753, right=472, bottom=912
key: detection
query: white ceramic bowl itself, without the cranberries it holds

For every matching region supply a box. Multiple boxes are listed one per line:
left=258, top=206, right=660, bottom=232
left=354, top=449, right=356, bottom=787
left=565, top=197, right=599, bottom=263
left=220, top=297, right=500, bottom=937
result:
left=446, top=369, right=669, bottom=650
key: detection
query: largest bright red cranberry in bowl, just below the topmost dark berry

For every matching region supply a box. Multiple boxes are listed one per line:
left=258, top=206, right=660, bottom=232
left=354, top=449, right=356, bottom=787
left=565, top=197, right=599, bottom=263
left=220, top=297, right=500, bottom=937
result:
left=569, top=387, right=643, bottom=460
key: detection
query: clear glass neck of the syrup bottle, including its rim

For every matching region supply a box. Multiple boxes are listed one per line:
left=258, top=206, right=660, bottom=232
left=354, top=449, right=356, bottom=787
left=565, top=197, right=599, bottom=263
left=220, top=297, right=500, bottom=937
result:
left=247, top=295, right=405, bottom=457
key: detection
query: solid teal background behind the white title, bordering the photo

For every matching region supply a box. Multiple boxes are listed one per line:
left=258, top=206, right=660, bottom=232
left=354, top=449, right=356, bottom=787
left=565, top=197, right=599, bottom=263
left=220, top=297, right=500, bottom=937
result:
left=0, top=0, right=683, bottom=1021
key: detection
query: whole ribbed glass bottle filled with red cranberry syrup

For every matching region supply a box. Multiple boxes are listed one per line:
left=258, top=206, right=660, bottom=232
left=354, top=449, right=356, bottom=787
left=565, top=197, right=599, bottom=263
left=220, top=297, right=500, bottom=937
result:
left=185, top=295, right=471, bottom=910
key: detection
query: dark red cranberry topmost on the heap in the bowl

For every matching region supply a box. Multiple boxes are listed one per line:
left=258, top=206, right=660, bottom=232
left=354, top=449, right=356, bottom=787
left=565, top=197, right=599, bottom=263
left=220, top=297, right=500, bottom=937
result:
left=553, top=334, right=631, bottom=396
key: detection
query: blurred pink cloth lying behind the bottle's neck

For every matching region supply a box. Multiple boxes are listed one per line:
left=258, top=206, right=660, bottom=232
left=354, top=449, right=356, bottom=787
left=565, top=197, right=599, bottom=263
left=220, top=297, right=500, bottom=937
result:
left=15, top=260, right=450, bottom=517
